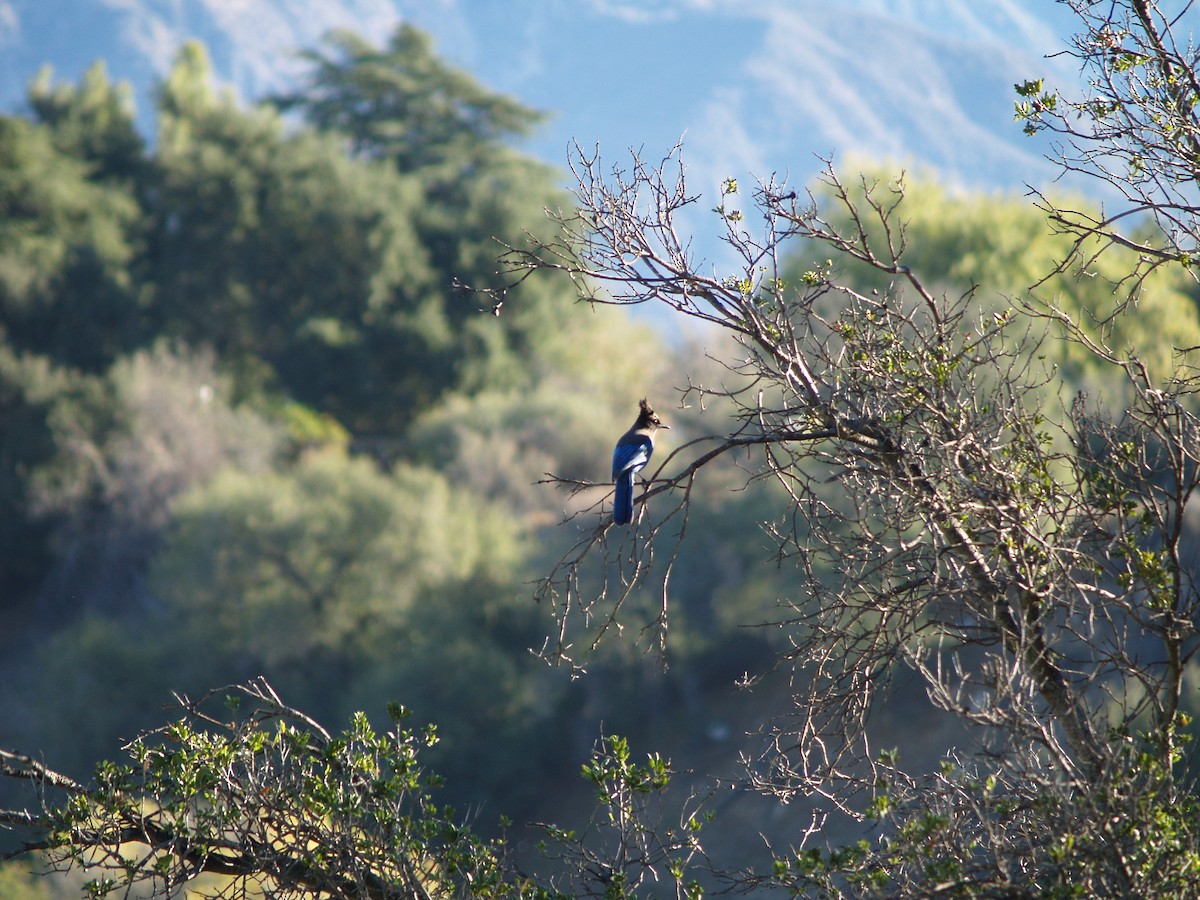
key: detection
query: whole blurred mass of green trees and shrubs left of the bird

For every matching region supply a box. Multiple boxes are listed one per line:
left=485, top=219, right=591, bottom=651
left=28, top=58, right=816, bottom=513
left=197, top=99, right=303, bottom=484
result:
left=0, top=28, right=700, bottom=830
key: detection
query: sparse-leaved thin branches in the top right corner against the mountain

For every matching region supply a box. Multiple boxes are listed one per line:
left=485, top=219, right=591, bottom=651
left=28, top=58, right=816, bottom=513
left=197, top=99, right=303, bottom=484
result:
left=1016, top=0, right=1200, bottom=296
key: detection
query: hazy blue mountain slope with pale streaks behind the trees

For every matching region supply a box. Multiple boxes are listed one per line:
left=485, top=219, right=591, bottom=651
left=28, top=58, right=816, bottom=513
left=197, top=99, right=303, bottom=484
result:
left=0, top=0, right=1075, bottom=264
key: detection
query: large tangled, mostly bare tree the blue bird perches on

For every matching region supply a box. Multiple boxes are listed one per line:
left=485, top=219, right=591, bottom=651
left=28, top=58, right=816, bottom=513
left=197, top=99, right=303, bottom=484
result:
left=487, top=65, right=1200, bottom=896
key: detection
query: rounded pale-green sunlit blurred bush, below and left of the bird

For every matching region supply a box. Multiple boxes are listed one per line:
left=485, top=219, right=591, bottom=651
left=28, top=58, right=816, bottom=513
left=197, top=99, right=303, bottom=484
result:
left=151, top=449, right=521, bottom=672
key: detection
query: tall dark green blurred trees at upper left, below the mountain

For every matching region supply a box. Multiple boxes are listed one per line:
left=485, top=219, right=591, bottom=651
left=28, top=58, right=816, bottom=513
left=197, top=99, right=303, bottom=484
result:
left=0, top=17, right=595, bottom=606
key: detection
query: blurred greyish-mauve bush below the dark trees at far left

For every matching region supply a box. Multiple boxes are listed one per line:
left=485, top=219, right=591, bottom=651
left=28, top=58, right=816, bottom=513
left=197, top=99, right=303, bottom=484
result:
left=28, top=343, right=282, bottom=612
